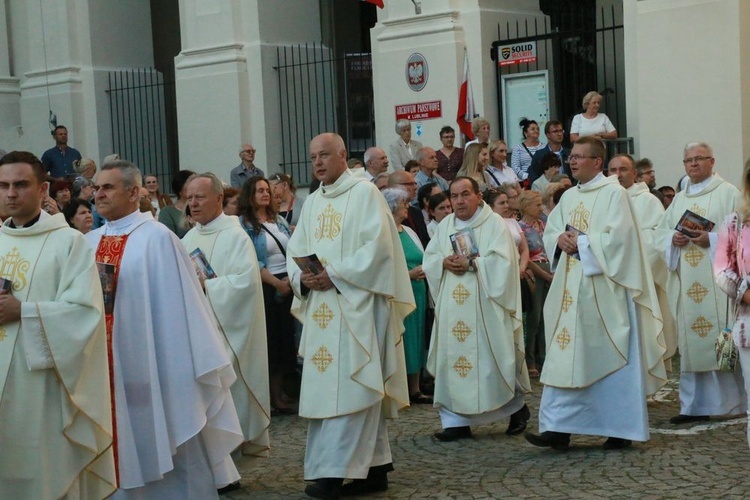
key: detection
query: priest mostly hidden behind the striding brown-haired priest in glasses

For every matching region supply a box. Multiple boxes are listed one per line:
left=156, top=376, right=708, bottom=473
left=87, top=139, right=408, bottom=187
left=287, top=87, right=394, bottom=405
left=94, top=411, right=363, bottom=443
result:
left=607, top=154, right=677, bottom=374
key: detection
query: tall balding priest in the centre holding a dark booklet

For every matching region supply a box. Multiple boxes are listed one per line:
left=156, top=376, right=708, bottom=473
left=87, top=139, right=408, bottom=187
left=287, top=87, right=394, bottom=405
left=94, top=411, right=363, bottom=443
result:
left=287, top=133, right=415, bottom=498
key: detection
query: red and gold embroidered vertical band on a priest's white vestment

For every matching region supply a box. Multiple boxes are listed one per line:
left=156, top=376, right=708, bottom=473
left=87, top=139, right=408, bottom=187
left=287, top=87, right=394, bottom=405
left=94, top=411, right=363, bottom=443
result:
left=96, top=234, right=128, bottom=487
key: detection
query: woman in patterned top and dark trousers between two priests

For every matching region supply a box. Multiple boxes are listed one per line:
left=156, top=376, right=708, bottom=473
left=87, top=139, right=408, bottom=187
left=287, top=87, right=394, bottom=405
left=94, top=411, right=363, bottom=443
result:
left=518, top=191, right=552, bottom=377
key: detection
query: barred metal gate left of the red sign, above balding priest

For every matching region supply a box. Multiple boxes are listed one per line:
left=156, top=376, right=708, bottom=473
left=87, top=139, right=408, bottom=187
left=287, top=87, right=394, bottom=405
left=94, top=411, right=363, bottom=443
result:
left=274, top=43, right=375, bottom=186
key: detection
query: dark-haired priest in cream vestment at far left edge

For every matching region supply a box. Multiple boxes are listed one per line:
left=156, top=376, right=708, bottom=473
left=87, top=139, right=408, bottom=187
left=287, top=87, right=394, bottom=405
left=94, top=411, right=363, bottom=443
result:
left=0, top=151, right=117, bottom=498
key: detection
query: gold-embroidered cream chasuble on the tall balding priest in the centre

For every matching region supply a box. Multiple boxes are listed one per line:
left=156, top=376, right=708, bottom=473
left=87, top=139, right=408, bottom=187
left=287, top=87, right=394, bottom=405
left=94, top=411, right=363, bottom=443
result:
left=287, top=171, right=415, bottom=418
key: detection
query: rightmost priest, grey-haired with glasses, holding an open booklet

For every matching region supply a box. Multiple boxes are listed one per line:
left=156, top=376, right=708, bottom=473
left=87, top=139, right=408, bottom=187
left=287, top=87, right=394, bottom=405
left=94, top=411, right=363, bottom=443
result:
left=656, top=142, right=747, bottom=424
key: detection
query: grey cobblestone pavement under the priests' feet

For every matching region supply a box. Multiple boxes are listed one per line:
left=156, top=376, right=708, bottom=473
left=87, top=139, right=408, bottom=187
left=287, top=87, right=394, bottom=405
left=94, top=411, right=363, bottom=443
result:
left=224, top=374, right=750, bottom=500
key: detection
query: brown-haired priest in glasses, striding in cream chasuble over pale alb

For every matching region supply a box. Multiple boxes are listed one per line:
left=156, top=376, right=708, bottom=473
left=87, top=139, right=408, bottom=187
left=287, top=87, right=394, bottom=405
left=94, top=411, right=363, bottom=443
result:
left=526, top=137, right=666, bottom=449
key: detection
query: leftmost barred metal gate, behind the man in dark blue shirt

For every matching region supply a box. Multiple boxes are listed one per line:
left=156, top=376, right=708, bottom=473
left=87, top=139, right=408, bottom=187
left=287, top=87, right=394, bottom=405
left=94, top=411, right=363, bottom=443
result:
left=107, top=68, right=179, bottom=193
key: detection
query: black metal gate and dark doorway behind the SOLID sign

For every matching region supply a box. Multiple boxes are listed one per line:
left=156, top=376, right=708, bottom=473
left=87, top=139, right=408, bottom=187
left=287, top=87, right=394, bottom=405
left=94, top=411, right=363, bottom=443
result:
left=492, top=1, right=632, bottom=152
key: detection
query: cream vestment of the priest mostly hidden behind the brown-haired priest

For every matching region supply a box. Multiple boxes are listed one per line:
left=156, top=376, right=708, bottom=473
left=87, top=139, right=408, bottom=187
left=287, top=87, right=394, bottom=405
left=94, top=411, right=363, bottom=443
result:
left=628, top=182, right=677, bottom=371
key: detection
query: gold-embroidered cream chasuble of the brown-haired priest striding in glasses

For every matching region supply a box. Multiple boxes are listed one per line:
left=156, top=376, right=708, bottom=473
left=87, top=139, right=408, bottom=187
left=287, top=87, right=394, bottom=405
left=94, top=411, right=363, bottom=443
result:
left=541, top=177, right=666, bottom=393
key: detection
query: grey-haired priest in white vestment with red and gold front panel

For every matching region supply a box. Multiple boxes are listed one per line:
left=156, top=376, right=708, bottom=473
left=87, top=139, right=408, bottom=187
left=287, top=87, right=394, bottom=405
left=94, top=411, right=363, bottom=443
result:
left=86, top=160, right=244, bottom=498
